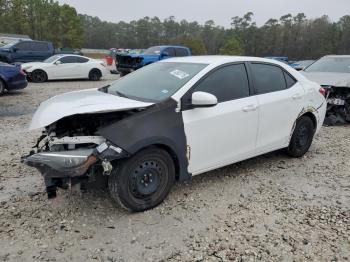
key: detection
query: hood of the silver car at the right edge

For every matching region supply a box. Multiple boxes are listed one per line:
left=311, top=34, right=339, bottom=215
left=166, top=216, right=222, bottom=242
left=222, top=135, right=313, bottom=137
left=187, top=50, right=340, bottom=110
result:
left=300, top=71, right=350, bottom=87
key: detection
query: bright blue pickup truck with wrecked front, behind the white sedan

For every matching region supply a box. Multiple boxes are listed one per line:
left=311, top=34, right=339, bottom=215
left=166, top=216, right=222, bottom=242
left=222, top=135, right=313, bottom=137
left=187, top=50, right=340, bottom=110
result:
left=116, top=45, right=191, bottom=76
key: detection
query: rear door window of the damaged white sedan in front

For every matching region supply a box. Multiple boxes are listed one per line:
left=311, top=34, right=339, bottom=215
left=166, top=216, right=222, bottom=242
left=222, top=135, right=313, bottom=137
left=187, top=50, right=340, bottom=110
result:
left=251, top=63, right=286, bottom=95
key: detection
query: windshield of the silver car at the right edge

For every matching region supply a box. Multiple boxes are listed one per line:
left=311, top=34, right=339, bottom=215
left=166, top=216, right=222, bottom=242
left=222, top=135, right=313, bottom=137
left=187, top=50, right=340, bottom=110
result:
left=305, top=56, right=350, bottom=73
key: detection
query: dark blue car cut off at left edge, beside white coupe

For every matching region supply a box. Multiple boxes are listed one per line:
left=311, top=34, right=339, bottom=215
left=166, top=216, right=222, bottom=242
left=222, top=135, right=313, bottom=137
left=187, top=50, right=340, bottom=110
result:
left=0, top=62, right=28, bottom=95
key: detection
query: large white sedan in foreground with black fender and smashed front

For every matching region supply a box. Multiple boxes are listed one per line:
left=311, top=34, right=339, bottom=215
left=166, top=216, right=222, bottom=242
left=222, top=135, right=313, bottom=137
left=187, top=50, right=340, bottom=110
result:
left=23, top=56, right=327, bottom=211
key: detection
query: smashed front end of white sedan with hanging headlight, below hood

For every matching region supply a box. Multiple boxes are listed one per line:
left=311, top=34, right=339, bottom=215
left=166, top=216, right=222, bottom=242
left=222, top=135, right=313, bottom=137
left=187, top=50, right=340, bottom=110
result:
left=22, top=110, right=132, bottom=198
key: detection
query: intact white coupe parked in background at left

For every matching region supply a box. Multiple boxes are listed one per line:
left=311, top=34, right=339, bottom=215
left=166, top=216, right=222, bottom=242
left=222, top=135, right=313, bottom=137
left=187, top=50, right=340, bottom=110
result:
left=22, top=55, right=106, bottom=83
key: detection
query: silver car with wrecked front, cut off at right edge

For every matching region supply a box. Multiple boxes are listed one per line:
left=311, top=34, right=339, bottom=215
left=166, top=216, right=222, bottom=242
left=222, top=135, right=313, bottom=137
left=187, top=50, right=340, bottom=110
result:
left=302, top=55, right=350, bottom=125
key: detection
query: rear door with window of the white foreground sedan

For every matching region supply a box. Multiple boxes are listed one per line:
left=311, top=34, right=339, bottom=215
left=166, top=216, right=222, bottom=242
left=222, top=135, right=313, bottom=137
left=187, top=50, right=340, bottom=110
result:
left=250, top=63, right=305, bottom=153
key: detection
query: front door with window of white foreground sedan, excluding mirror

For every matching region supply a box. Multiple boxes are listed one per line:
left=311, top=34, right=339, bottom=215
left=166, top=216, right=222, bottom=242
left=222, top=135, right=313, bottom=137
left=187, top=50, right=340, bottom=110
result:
left=181, top=63, right=258, bottom=175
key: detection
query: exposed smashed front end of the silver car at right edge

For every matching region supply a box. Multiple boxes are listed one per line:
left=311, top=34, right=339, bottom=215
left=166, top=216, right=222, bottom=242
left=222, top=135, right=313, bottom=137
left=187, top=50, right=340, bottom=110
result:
left=322, top=85, right=350, bottom=125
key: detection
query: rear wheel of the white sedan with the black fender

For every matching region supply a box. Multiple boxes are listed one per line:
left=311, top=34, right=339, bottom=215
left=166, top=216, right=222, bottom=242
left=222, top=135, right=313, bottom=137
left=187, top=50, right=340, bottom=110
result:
left=287, top=116, right=315, bottom=157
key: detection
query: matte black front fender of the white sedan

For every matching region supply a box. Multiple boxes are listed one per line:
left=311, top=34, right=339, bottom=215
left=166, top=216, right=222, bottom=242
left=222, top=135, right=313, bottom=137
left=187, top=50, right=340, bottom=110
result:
left=98, top=99, right=190, bottom=180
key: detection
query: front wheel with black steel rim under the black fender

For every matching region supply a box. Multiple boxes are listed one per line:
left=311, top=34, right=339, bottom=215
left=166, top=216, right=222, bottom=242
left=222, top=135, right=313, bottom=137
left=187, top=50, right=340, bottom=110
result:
left=108, top=148, right=175, bottom=212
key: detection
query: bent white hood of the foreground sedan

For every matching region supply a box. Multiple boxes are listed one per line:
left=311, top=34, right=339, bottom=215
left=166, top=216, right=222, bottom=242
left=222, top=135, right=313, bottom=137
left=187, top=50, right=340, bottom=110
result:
left=29, top=89, right=152, bottom=130
